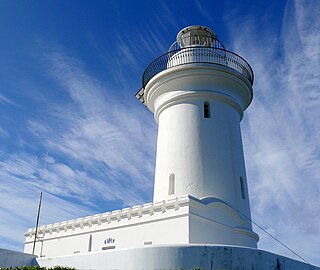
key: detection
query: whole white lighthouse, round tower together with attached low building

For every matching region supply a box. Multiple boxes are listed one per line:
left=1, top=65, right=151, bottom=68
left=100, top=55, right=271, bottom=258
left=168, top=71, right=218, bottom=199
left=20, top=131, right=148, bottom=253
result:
left=24, top=26, right=316, bottom=269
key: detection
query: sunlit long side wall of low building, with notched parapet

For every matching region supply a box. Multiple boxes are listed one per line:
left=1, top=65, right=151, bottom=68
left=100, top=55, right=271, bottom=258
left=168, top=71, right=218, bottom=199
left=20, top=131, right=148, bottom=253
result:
left=24, top=197, right=189, bottom=257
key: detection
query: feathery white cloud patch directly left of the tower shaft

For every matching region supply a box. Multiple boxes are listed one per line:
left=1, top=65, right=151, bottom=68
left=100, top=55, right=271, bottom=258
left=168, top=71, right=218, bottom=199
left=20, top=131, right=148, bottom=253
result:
left=40, top=49, right=155, bottom=205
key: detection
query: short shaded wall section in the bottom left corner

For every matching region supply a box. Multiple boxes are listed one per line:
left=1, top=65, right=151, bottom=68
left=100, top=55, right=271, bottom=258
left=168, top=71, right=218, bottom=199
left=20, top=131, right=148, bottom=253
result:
left=0, top=248, right=37, bottom=268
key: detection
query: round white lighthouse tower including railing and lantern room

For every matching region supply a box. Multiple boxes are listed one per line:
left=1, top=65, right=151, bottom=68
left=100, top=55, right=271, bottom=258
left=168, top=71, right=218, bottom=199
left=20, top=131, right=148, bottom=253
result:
left=136, top=26, right=257, bottom=247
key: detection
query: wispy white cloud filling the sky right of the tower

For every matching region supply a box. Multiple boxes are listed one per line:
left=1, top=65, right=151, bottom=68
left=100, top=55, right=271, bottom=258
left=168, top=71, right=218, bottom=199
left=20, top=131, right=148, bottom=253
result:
left=226, top=1, right=320, bottom=260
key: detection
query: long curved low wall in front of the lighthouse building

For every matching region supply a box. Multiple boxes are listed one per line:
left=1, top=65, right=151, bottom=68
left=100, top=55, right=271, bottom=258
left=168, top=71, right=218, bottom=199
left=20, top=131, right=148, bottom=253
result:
left=36, top=245, right=320, bottom=270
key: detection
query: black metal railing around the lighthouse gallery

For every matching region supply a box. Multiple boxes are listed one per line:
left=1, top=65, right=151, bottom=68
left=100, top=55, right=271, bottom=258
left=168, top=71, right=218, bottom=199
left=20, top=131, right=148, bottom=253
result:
left=142, top=46, right=253, bottom=88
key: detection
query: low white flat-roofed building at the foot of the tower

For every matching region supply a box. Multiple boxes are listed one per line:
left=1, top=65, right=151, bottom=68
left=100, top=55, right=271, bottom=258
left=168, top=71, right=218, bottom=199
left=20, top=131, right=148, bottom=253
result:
left=24, top=196, right=259, bottom=257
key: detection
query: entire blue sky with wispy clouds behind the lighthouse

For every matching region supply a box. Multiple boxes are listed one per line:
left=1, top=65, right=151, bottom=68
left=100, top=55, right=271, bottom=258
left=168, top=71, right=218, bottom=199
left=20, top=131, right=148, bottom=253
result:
left=0, top=0, right=320, bottom=265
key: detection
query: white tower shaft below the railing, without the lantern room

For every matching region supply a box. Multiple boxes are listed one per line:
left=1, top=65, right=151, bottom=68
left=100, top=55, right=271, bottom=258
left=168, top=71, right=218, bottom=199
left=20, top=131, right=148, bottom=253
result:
left=145, top=64, right=258, bottom=247
